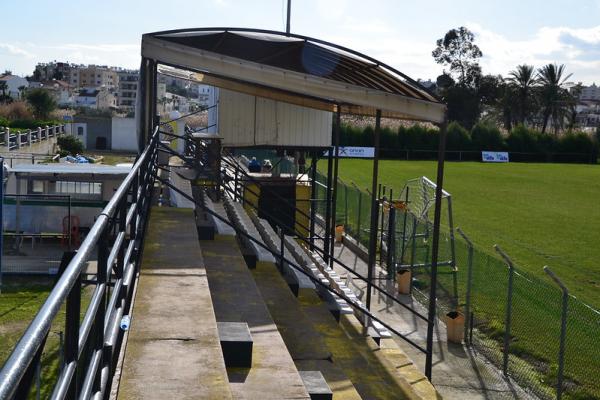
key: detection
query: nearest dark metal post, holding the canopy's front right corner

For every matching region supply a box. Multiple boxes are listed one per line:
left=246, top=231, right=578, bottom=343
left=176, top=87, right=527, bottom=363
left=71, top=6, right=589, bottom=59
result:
left=425, top=117, right=448, bottom=381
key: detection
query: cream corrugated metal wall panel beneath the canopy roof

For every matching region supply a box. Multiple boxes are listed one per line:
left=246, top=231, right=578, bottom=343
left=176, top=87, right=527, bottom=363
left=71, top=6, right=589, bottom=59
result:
left=216, top=89, right=332, bottom=147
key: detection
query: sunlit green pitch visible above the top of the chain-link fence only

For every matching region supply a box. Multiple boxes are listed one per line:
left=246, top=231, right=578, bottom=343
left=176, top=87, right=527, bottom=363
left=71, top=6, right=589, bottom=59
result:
left=332, top=159, right=600, bottom=308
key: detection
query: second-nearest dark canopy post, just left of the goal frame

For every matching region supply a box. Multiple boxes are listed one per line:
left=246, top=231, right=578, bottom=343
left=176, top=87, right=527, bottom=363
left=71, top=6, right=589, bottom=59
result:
left=365, top=109, right=381, bottom=312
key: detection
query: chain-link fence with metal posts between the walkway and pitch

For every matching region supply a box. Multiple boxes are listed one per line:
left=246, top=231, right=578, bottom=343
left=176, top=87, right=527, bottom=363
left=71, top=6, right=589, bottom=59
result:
left=317, top=176, right=600, bottom=399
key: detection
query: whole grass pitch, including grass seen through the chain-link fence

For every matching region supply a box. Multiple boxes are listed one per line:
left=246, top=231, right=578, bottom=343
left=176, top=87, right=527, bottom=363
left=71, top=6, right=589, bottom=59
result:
left=328, top=160, right=600, bottom=399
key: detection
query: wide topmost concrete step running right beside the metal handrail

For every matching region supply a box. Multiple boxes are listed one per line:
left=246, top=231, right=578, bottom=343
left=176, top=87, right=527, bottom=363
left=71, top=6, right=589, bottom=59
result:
left=117, top=207, right=232, bottom=399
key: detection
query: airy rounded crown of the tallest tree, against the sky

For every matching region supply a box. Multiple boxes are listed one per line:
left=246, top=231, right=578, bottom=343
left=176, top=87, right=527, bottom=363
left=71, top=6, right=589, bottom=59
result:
left=431, top=26, right=482, bottom=86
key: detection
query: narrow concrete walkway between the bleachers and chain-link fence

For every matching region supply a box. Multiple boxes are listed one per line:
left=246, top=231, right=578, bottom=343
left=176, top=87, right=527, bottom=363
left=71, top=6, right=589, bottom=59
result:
left=326, top=239, right=532, bottom=400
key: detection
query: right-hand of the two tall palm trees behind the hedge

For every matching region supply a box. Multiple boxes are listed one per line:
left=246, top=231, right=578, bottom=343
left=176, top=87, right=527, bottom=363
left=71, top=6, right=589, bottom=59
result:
left=537, top=64, right=572, bottom=133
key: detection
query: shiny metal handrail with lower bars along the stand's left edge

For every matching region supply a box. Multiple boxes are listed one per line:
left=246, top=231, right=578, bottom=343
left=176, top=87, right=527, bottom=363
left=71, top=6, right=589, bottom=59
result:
left=0, top=128, right=158, bottom=399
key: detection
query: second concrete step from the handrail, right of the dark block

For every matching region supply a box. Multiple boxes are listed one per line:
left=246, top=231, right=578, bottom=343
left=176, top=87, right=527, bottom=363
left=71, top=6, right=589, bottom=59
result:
left=200, top=217, right=309, bottom=399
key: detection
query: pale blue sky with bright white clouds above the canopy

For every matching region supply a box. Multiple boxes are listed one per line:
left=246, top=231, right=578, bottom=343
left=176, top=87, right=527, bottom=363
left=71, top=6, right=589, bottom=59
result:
left=0, top=0, right=600, bottom=84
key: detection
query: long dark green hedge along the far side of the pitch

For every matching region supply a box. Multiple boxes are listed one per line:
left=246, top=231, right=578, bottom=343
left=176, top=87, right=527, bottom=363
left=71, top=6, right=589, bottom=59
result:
left=340, top=122, right=600, bottom=163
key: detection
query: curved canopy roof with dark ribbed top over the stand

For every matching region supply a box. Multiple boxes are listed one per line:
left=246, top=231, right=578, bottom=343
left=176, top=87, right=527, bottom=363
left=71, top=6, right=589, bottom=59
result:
left=142, top=28, right=445, bottom=123
